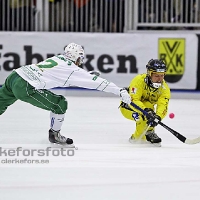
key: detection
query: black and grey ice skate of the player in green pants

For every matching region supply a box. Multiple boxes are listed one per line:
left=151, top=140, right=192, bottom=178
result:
left=49, top=129, right=75, bottom=148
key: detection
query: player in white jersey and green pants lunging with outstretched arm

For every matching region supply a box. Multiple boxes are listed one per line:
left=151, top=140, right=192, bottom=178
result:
left=0, top=43, right=131, bottom=146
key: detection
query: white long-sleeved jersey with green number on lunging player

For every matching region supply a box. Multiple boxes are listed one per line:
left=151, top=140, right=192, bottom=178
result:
left=16, top=55, right=121, bottom=96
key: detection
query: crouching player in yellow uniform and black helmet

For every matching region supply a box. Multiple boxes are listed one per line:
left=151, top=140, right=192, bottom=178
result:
left=120, top=59, right=170, bottom=146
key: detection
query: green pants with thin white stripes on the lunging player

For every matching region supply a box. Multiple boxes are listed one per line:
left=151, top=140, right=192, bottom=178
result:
left=0, top=71, right=67, bottom=115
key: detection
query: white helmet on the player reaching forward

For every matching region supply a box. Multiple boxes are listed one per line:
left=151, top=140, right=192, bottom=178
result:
left=64, top=43, right=85, bottom=65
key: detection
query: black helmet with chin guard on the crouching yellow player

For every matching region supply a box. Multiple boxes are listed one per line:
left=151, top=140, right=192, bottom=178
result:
left=146, top=59, right=167, bottom=88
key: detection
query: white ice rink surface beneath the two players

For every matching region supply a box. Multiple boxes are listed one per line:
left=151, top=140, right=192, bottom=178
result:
left=0, top=96, right=200, bottom=200
